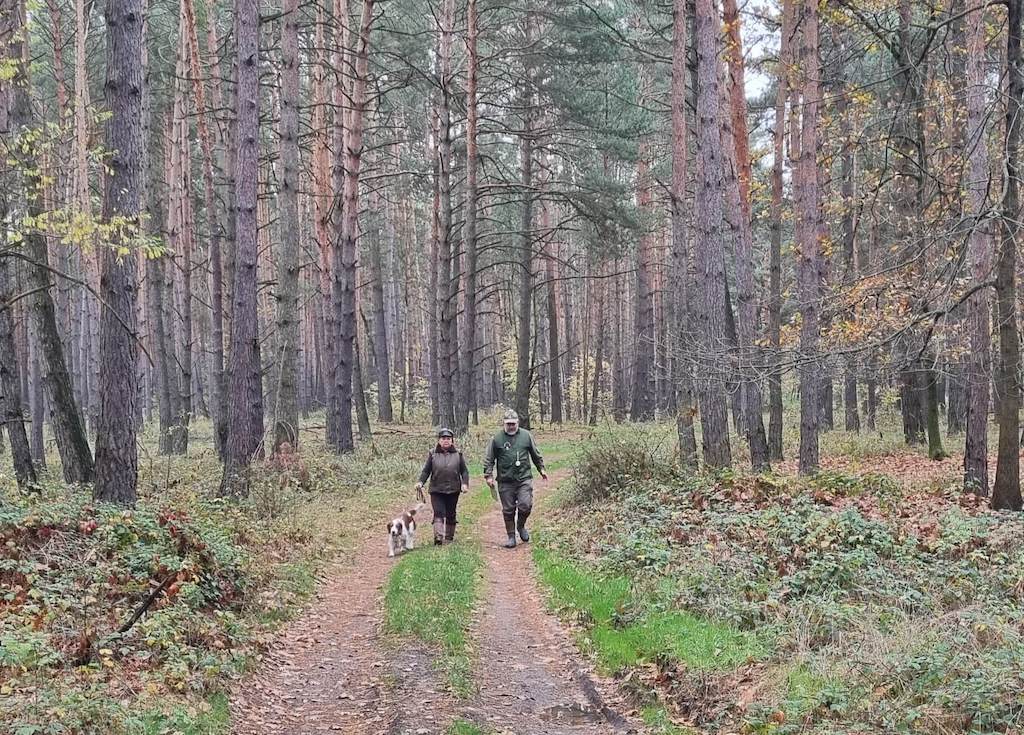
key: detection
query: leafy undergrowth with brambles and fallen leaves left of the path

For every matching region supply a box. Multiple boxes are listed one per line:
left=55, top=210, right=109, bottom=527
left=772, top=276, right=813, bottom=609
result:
left=0, top=424, right=440, bottom=735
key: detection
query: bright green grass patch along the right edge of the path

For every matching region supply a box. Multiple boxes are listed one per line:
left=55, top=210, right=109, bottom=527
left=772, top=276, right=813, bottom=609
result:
left=534, top=546, right=763, bottom=672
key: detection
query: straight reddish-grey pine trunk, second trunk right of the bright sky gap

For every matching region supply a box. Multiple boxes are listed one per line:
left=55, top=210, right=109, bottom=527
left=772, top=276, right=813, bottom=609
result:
left=795, top=0, right=822, bottom=475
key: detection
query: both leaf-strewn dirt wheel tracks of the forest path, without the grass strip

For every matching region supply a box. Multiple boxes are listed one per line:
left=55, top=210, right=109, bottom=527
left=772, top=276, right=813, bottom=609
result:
left=231, top=462, right=642, bottom=735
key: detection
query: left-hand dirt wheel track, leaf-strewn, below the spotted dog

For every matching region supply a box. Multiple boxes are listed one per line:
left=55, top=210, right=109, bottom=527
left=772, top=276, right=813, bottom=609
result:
left=231, top=522, right=451, bottom=735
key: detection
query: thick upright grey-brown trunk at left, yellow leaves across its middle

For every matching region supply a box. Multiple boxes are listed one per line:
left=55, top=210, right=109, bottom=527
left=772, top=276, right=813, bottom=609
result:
left=93, top=0, right=145, bottom=506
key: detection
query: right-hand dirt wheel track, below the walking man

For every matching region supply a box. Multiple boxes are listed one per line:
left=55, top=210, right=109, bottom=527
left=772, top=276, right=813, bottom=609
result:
left=462, top=472, right=643, bottom=735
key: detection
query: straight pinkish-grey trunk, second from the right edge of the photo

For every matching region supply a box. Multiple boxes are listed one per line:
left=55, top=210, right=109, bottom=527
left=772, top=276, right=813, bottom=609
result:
left=964, top=0, right=1001, bottom=496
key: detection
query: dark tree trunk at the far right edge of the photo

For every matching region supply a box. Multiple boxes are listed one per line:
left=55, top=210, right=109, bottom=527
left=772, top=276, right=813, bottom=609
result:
left=992, top=0, right=1024, bottom=511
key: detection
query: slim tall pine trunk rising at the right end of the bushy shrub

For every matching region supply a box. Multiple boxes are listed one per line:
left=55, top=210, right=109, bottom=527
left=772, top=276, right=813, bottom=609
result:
left=669, top=0, right=697, bottom=467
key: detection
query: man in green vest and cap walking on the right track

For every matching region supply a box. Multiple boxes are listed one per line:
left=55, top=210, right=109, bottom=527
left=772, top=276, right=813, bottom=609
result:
left=483, top=410, right=548, bottom=549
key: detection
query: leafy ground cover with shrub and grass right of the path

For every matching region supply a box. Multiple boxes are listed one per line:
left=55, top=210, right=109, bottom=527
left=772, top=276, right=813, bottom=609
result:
left=535, top=433, right=1024, bottom=734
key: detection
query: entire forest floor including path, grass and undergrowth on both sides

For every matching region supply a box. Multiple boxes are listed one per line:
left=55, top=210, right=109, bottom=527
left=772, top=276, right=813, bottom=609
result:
left=0, top=417, right=1024, bottom=735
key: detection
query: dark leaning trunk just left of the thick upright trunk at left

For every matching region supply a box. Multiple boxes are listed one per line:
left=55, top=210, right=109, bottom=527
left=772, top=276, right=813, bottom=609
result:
left=8, top=2, right=94, bottom=484
